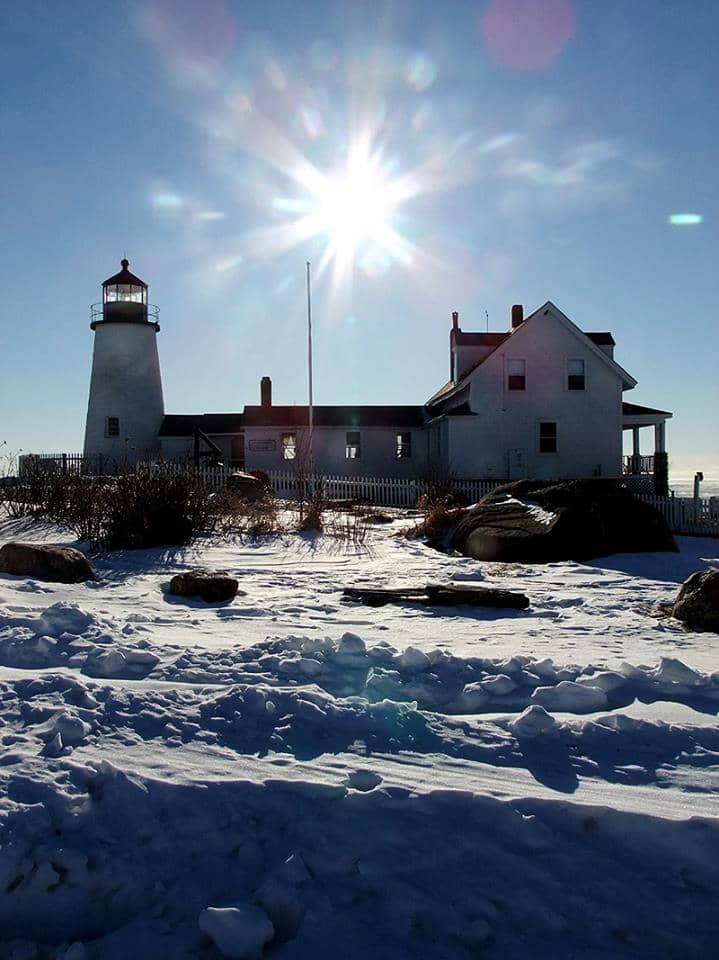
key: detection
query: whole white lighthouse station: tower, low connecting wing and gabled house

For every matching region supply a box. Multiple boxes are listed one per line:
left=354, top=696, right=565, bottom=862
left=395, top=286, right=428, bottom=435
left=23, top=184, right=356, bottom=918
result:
left=84, top=260, right=672, bottom=492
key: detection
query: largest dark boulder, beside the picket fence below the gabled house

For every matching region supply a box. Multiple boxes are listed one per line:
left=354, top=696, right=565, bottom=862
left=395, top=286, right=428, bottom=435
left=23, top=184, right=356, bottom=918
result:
left=448, top=480, right=677, bottom=563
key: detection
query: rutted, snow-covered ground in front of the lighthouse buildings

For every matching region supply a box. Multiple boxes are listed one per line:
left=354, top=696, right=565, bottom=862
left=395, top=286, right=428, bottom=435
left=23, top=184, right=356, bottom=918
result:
left=0, top=521, right=719, bottom=960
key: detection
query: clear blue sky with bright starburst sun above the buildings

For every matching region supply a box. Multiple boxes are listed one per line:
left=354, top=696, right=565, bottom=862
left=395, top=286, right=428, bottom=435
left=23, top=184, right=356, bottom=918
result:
left=0, top=0, right=719, bottom=473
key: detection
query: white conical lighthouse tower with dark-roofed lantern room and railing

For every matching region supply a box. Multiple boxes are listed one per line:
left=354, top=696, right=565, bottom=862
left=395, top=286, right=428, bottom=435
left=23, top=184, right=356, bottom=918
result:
left=84, top=260, right=165, bottom=472
